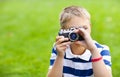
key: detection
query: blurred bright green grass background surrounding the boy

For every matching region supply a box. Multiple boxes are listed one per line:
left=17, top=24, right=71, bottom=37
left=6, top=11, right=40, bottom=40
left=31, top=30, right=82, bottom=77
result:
left=0, top=0, right=120, bottom=77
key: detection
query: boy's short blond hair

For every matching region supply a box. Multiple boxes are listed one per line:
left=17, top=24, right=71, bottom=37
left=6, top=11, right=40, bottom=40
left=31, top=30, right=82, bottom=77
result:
left=60, top=6, right=90, bottom=27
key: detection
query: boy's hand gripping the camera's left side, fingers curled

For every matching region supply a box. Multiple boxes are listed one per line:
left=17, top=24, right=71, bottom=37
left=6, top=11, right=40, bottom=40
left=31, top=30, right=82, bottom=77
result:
left=55, top=36, right=71, bottom=57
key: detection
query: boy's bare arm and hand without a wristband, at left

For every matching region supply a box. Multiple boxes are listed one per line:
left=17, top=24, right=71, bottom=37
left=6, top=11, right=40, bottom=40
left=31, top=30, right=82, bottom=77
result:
left=47, top=36, right=70, bottom=77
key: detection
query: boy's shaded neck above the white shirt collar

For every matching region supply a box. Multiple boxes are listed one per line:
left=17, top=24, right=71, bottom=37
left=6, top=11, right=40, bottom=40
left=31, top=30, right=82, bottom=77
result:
left=70, top=44, right=86, bottom=55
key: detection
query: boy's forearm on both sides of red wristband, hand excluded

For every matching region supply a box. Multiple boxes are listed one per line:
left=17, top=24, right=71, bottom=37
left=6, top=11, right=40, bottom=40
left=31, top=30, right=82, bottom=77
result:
left=92, top=47, right=112, bottom=77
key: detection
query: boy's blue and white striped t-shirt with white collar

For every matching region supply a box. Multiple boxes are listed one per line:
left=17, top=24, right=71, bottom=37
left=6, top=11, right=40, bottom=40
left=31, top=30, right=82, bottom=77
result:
left=49, top=42, right=111, bottom=77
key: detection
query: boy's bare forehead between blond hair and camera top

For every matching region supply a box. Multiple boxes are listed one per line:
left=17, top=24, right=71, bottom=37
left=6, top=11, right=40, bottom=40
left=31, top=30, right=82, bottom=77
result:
left=64, top=17, right=90, bottom=28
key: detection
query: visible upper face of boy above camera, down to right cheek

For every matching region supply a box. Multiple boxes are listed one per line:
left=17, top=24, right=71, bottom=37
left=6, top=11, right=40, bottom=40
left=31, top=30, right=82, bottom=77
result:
left=65, top=16, right=91, bottom=33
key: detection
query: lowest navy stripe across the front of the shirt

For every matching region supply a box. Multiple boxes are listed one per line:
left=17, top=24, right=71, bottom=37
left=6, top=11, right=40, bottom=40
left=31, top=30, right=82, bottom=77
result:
left=63, top=66, right=93, bottom=77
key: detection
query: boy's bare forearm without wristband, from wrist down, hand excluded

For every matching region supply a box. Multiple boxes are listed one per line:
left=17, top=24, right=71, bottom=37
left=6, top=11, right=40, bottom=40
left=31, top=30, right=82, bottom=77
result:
left=47, top=56, right=64, bottom=77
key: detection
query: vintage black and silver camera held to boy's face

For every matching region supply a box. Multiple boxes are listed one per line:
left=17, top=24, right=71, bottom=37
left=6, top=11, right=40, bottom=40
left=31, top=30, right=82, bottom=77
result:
left=58, top=28, right=84, bottom=42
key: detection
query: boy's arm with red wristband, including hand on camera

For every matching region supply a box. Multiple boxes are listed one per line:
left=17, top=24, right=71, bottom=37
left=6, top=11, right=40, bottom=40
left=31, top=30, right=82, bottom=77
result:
left=77, top=29, right=112, bottom=77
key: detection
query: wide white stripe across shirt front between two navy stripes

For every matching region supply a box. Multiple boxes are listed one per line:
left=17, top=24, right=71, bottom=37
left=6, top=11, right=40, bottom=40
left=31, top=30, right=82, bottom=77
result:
left=64, top=59, right=92, bottom=70
